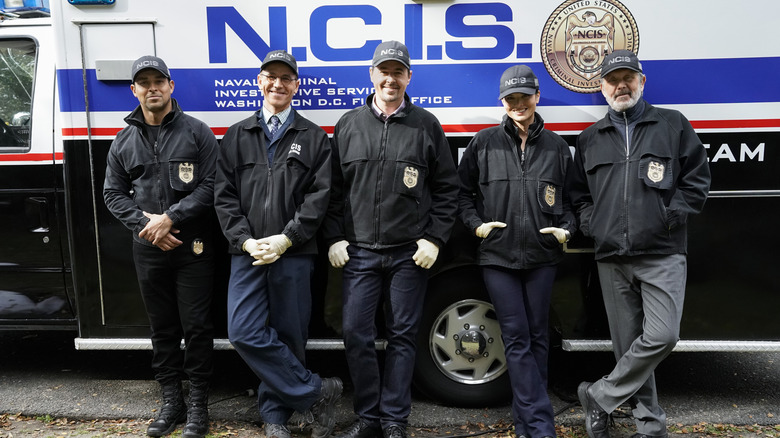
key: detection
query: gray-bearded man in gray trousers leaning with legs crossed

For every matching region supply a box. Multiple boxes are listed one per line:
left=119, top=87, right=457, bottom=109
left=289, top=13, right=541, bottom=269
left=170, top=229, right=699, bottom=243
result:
left=570, top=50, right=710, bottom=438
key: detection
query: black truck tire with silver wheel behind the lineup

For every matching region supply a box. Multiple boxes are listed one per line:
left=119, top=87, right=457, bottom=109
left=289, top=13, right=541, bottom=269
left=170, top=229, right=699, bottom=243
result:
left=415, top=267, right=511, bottom=407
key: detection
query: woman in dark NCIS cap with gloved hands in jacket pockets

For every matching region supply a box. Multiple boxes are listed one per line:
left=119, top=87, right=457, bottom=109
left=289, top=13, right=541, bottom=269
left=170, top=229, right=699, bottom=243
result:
left=458, top=65, right=576, bottom=438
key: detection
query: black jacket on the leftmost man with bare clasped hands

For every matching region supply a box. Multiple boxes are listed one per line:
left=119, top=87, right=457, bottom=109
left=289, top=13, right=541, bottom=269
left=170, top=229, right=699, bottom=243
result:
left=103, top=99, right=217, bottom=246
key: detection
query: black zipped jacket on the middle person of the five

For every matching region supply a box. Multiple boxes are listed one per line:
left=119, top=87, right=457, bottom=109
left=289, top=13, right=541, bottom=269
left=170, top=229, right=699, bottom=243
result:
left=323, top=94, right=458, bottom=249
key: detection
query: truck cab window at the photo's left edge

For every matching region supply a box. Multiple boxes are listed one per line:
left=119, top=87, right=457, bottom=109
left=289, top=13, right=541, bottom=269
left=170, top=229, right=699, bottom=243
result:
left=0, top=38, right=37, bottom=153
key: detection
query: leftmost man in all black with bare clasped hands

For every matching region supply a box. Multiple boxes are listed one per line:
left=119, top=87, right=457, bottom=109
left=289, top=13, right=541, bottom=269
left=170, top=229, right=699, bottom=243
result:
left=103, top=56, right=217, bottom=438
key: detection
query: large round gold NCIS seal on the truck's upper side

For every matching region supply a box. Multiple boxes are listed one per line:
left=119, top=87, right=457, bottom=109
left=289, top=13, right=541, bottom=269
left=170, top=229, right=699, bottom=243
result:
left=539, top=0, right=639, bottom=93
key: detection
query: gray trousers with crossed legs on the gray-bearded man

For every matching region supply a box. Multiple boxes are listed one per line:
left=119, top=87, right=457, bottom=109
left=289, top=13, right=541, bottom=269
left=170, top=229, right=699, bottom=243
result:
left=591, top=254, right=687, bottom=436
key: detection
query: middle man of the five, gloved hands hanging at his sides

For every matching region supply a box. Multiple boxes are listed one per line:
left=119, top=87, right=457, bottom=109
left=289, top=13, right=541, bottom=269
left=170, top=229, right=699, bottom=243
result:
left=323, top=41, right=458, bottom=438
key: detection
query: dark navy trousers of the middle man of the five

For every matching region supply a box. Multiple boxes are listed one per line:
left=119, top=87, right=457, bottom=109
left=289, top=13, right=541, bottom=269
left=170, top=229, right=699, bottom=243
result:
left=343, top=243, right=428, bottom=428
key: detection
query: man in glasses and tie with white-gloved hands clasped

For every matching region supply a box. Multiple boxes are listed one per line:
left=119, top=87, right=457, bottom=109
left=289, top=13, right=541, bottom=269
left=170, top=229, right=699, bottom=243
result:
left=214, top=50, right=342, bottom=438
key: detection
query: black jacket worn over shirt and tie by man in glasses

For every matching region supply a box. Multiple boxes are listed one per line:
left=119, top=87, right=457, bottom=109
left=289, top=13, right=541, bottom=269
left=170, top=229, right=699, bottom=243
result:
left=214, top=110, right=331, bottom=254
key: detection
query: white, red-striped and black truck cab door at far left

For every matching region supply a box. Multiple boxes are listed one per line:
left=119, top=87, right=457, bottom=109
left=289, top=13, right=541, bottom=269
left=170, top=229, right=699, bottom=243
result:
left=0, top=23, right=75, bottom=328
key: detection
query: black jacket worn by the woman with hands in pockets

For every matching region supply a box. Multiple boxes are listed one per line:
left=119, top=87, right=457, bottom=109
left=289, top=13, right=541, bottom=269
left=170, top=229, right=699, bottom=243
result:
left=458, top=113, right=575, bottom=269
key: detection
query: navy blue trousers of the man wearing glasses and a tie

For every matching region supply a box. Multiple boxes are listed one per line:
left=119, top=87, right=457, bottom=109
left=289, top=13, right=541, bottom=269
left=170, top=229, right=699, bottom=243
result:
left=228, top=254, right=322, bottom=424
